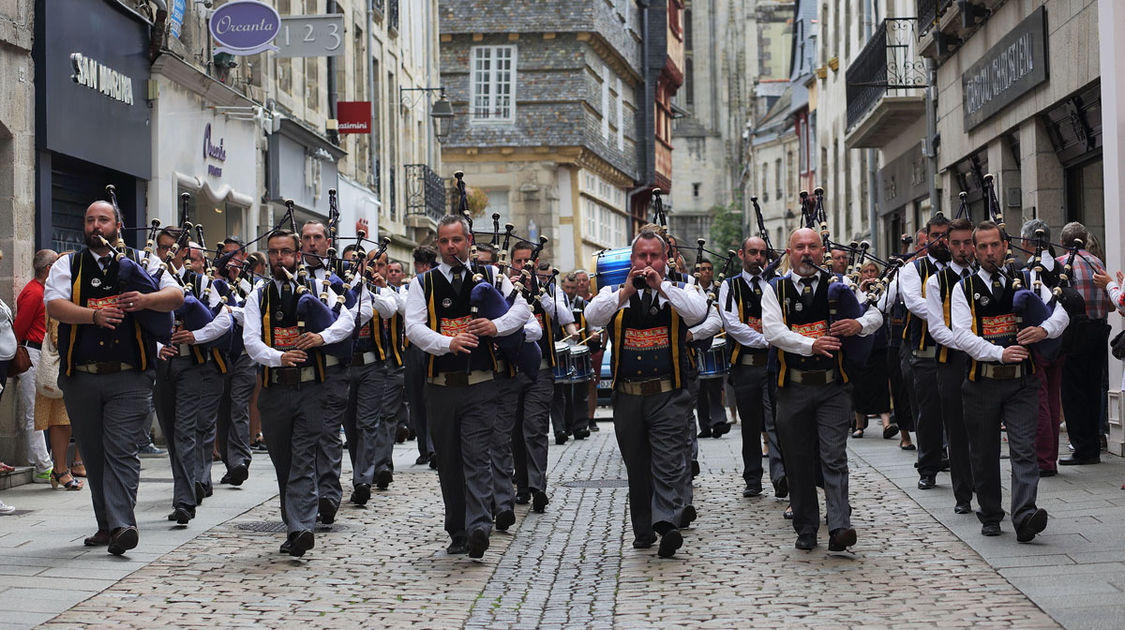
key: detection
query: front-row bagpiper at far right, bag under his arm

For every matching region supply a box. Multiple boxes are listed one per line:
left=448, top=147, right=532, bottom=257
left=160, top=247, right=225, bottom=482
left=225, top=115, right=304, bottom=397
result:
left=950, top=221, right=1070, bottom=542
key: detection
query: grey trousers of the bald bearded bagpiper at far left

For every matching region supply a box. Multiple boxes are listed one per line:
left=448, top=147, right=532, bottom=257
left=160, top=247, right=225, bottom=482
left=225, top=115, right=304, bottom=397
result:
left=59, top=370, right=153, bottom=531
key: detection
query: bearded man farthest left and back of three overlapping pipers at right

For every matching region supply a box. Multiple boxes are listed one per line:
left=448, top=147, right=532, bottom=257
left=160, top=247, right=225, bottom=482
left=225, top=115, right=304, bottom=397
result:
left=899, top=214, right=951, bottom=491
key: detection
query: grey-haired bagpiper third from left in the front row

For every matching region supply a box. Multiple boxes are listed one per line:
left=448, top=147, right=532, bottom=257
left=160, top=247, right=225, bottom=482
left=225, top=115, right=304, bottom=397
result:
left=406, top=215, right=528, bottom=558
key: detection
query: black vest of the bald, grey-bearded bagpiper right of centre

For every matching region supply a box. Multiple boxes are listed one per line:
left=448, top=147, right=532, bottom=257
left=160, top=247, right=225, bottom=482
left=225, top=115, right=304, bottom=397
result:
left=771, top=273, right=848, bottom=387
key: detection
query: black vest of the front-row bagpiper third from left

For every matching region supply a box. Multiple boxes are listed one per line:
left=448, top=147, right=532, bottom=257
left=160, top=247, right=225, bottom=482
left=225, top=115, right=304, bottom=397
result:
left=422, top=268, right=500, bottom=377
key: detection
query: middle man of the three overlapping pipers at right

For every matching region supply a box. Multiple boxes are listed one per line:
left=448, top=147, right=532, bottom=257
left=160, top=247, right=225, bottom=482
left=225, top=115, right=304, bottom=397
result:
left=919, top=218, right=981, bottom=514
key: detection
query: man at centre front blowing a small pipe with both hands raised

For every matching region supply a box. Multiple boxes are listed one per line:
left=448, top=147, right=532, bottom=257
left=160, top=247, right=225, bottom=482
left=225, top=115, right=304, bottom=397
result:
left=586, top=230, right=708, bottom=558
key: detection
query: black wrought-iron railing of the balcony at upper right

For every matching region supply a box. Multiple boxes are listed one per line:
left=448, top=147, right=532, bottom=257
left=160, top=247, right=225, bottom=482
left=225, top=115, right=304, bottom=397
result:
left=845, top=18, right=927, bottom=129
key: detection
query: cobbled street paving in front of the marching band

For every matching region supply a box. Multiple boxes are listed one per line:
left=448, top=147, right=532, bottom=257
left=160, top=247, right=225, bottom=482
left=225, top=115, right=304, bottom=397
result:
left=21, top=405, right=1058, bottom=629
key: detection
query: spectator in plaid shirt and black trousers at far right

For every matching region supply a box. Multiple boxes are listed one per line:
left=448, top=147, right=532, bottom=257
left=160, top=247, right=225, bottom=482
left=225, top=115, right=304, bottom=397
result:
left=1056, top=222, right=1114, bottom=466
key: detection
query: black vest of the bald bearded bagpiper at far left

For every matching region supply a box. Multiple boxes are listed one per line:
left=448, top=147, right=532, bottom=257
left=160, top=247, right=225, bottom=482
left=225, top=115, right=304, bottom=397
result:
left=56, top=248, right=156, bottom=376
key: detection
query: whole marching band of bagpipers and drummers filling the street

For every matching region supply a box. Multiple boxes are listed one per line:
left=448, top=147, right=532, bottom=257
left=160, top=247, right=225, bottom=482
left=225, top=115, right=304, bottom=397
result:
left=26, top=173, right=1119, bottom=558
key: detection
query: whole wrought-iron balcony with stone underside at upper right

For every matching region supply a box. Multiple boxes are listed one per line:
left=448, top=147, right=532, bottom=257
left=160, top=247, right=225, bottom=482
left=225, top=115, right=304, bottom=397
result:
left=845, top=18, right=928, bottom=149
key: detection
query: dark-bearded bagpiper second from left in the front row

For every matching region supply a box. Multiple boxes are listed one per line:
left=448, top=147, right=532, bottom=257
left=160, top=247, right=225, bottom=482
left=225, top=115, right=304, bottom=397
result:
left=242, top=230, right=353, bottom=557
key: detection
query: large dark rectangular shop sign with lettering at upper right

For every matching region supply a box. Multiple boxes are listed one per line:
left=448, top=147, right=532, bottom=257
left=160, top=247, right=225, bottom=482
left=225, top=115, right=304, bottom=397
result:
left=961, top=7, right=1047, bottom=131
